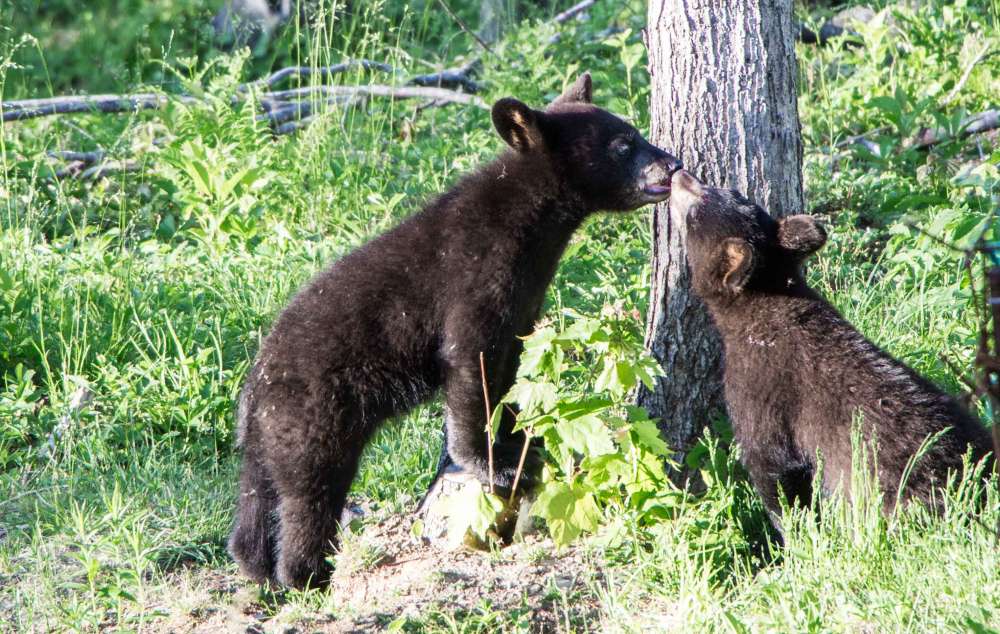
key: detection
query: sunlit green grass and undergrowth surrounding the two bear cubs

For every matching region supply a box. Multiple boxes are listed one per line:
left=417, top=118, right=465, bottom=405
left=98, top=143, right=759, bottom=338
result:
left=0, top=0, right=1000, bottom=632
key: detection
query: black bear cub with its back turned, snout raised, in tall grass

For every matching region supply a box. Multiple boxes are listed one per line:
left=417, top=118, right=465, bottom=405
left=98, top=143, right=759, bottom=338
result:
left=670, top=171, right=991, bottom=519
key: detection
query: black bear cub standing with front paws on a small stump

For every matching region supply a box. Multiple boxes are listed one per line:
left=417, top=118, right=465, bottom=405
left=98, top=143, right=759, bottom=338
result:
left=229, top=74, right=680, bottom=587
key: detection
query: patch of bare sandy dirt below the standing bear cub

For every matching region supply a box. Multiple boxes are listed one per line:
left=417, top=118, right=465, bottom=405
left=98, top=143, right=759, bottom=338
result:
left=144, top=516, right=602, bottom=634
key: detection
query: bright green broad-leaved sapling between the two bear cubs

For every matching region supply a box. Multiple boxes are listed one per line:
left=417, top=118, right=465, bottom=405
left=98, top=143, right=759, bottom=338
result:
left=494, top=308, right=676, bottom=545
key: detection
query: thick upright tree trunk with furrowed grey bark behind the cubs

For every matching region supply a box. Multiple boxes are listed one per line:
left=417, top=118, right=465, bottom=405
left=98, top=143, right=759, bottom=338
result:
left=638, top=0, right=803, bottom=462
